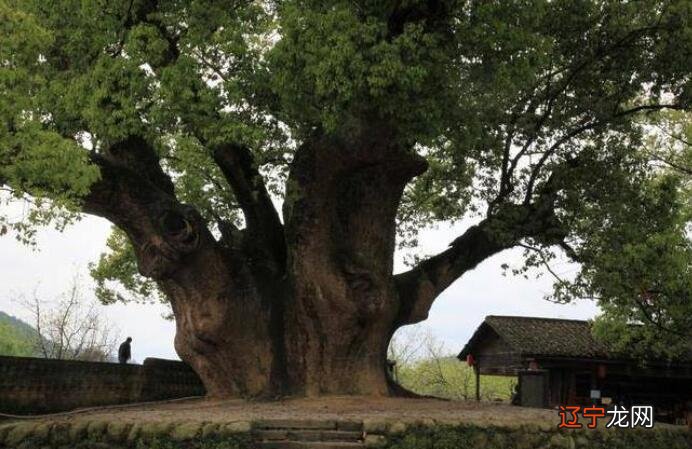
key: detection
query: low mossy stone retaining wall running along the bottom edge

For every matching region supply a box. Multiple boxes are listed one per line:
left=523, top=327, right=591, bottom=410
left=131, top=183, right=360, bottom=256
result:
left=0, top=419, right=692, bottom=449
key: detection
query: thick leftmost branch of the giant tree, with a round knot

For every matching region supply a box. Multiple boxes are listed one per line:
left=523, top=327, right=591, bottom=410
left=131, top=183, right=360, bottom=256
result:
left=82, top=137, right=215, bottom=280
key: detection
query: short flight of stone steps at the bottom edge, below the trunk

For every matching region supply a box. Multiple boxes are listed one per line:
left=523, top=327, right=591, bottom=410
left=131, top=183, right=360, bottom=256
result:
left=252, top=420, right=365, bottom=449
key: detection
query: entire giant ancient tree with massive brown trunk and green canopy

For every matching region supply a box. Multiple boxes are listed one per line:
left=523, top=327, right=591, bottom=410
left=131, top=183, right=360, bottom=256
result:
left=0, top=0, right=692, bottom=397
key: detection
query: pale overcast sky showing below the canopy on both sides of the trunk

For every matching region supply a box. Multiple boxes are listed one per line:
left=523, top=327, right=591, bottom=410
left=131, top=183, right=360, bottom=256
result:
left=0, top=212, right=598, bottom=363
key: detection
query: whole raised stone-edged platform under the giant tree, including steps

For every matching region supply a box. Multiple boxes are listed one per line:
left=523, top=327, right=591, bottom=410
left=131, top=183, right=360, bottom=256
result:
left=0, top=397, right=692, bottom=449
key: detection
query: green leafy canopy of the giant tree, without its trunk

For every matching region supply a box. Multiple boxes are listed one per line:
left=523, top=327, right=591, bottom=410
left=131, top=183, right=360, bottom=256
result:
left=0, top=0, right=692, bottom=354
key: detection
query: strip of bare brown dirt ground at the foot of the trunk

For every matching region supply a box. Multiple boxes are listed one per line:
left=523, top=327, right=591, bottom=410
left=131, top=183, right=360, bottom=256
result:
left=32, top=396, right=559, bottom=426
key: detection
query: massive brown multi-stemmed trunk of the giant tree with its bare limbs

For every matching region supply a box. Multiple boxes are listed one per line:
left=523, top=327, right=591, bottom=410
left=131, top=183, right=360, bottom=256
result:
left=78, top=132, right=564, bottom=397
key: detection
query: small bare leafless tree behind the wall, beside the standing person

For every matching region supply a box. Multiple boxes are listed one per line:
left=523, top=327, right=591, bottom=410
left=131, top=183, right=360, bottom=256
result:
left=23, top=277, right=118, bottom=362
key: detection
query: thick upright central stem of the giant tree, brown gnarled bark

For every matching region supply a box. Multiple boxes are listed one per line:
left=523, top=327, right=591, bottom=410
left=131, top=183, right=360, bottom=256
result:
left=284, top=131, right=425, bottom=395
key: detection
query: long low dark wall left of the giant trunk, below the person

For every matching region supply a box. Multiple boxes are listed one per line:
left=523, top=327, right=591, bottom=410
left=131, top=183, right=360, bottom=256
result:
left=0, top=356, right=204, bottom=414
